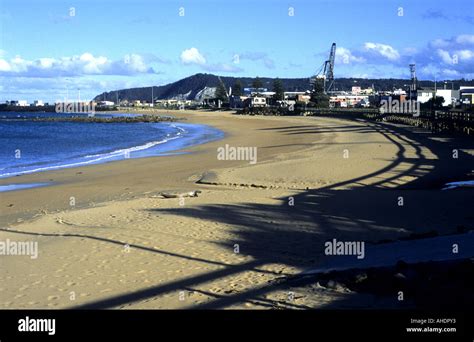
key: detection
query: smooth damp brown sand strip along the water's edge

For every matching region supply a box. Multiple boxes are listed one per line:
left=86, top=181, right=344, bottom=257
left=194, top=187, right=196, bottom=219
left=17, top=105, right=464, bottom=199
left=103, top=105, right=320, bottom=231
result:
left=0, top=110, right=320, bottom=225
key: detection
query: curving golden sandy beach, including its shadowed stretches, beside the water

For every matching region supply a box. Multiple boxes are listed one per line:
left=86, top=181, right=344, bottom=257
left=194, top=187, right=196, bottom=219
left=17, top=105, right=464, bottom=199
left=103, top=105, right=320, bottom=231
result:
left=0, top=111, right=474, bottom=309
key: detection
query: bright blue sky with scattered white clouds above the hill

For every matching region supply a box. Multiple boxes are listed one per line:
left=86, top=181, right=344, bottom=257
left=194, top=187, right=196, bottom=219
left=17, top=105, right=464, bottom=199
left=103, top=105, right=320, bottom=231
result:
left=0, top=0, right=474, bottom=101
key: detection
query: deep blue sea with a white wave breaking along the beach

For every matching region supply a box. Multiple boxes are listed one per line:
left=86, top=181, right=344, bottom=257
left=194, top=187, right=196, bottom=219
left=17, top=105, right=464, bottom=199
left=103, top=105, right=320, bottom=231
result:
left=0, top=113, right=224, bottom=182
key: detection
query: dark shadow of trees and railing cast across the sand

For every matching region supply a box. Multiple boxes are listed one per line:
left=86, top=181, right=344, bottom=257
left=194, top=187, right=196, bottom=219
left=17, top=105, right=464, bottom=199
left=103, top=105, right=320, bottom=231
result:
left=71, top=121, right=474, bottom=309
